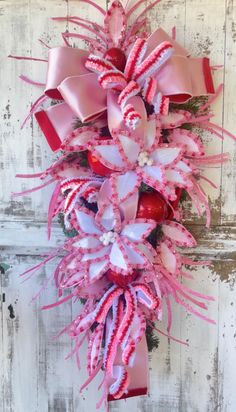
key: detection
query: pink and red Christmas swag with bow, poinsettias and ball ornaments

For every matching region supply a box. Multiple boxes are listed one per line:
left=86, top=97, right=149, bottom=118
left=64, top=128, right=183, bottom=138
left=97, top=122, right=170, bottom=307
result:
left=10, top=0, right=234, bottom=408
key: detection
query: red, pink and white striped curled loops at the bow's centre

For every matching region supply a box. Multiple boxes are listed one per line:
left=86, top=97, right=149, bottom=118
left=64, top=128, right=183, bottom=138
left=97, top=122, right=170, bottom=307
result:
left=85, top=38, right=173, bottom=129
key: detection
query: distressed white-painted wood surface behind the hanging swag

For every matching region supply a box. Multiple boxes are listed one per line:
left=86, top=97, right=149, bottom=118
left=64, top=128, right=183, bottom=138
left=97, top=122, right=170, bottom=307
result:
left=0, top=0, right=236, bottom=412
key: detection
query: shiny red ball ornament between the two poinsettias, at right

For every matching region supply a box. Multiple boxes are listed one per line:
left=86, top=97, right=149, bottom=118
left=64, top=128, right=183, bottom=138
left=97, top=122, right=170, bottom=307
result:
left=136, top=192, right=168, bottom=223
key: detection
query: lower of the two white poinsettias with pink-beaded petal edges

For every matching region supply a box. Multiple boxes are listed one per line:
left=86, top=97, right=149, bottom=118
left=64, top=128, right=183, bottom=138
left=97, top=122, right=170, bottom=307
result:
left=60, top=208, right=156, bottom=286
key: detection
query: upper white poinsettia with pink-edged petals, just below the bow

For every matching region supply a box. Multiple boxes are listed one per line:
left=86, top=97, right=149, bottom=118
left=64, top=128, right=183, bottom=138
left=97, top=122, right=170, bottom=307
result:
left=91, top=118, right=193, bottom=202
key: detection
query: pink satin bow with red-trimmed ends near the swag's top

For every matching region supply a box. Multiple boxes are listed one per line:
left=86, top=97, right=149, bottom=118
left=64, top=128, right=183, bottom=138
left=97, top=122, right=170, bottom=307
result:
left=36, top=28, right=215, bottom=151
